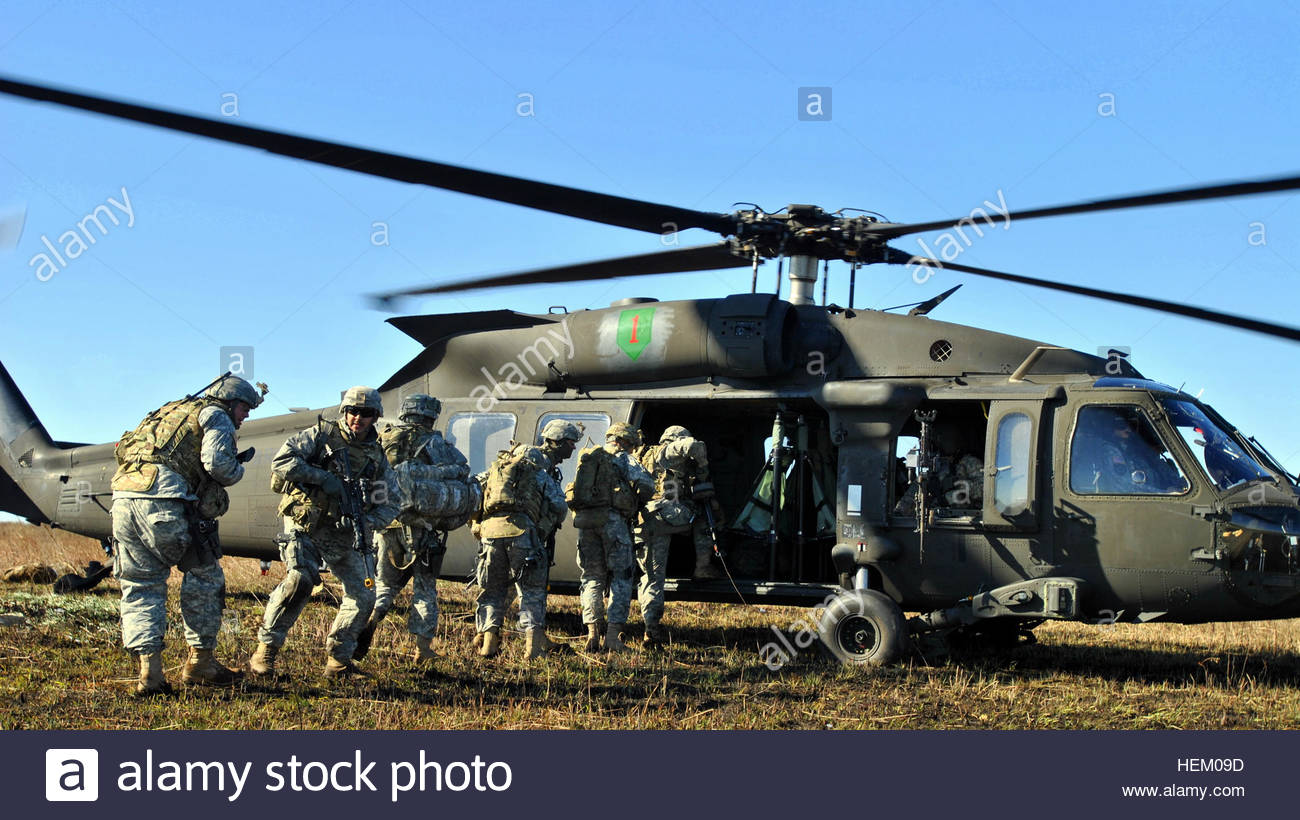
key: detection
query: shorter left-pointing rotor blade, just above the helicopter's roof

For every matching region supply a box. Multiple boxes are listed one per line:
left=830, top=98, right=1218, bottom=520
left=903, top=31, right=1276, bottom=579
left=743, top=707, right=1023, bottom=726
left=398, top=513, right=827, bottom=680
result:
left=372, top=242, right=762, bottom=307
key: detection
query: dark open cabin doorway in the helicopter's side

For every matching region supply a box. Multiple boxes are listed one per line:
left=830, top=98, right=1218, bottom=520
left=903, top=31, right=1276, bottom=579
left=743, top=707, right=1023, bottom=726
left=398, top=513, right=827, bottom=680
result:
left=637, top=400, right=837, bottom=583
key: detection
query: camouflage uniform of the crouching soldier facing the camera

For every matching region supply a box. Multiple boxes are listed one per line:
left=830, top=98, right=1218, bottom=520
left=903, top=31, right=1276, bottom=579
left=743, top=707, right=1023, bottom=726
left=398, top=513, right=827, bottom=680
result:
left=250, top=402, right=398, bottom=672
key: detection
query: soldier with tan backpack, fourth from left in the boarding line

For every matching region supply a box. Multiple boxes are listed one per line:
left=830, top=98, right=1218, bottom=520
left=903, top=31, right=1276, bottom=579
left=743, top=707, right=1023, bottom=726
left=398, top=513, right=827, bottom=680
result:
left=475, top=418, right=582, bottom=658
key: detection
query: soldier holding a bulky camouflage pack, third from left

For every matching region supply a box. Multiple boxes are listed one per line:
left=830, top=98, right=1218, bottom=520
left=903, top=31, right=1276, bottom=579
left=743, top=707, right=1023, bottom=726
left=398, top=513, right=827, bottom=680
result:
left=352, top=392, right=469, bottom=664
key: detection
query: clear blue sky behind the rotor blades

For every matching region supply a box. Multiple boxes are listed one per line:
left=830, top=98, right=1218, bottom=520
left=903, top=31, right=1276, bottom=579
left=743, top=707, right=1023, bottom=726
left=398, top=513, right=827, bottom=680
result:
left=0, top=0, right=1300, bottom=480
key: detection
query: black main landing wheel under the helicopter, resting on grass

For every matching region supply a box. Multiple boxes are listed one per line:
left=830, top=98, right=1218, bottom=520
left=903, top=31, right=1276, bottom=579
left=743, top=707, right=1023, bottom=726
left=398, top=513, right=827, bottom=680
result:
left=818, top=590, right=907, bottom=667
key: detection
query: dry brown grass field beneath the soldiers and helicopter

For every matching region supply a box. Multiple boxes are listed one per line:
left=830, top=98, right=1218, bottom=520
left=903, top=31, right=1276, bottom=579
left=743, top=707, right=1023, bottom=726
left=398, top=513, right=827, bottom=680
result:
left=0, top=524, right=1300, bottom=729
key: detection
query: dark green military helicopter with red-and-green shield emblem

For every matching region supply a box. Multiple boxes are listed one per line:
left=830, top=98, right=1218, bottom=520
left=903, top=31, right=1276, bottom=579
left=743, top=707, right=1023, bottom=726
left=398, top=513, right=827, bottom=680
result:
left=0, top=79, right=1300, bottom=663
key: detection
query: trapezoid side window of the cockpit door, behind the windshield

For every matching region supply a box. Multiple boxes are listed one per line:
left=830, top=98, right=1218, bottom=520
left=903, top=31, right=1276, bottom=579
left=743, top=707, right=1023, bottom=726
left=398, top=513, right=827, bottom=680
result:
left=1070, top=404, right=1192, bottom=495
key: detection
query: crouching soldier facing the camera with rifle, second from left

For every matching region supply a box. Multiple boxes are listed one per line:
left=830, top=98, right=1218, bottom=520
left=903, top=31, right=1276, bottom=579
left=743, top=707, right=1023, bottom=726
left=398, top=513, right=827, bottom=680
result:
left=248, top=387, right=398, bottom=677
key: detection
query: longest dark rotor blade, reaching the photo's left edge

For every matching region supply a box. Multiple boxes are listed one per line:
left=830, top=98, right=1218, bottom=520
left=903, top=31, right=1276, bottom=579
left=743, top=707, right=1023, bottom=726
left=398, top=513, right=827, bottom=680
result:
left=0, top=77, right=735, bottom=235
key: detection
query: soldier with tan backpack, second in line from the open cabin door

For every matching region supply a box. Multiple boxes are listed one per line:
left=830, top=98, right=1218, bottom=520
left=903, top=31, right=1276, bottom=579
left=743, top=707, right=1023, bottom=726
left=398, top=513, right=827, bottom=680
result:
left=566, top=421, right=655, bottom=652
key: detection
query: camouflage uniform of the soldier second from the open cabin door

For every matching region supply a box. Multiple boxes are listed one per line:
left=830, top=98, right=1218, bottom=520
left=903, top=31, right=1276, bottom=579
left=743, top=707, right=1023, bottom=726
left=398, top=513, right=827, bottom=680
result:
left=575, top=425, right=655, bottom=634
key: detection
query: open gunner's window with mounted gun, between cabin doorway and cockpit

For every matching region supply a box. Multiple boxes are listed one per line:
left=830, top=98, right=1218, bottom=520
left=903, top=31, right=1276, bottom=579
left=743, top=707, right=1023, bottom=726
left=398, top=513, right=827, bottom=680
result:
left=892, top=402, right=988, bottom=524
